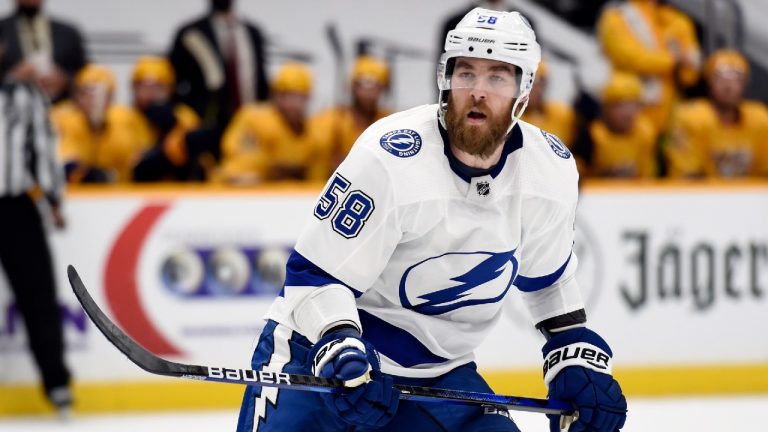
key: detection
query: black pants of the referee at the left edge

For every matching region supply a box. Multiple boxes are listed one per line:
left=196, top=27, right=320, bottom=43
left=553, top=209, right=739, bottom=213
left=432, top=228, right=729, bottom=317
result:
left=0, top=195, right=70, bottom=395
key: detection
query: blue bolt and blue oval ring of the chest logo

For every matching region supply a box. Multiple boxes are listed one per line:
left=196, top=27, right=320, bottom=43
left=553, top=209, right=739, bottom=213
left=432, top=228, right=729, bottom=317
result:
left=400, top=251, right=518, bottom=315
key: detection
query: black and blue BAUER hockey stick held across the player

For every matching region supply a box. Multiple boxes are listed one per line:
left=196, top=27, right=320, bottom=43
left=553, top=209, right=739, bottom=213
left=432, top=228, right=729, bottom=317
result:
left=67, top=265, right=573, bottom=415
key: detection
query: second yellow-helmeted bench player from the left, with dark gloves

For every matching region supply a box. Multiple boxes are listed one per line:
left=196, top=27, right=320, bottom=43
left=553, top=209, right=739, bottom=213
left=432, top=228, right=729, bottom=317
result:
left=131, top=56, right=202, bottom=182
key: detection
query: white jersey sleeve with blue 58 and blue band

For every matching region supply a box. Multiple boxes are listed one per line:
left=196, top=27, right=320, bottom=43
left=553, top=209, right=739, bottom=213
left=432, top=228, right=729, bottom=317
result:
left=267, top=134, right=402, bottom=341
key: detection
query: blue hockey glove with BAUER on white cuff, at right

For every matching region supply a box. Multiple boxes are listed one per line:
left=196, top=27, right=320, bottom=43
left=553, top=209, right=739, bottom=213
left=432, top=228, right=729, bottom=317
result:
left=541, top=327, right=627, bottom=432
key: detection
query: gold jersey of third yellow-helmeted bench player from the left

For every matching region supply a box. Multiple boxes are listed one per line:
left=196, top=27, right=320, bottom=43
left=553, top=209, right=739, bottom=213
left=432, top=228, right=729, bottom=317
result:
left=218, top=104, right=328, bottom=183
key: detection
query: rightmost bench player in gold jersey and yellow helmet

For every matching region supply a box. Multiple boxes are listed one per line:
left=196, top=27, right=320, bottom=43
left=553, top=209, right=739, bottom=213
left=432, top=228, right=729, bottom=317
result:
left=665, top=50, right=768, bottom=177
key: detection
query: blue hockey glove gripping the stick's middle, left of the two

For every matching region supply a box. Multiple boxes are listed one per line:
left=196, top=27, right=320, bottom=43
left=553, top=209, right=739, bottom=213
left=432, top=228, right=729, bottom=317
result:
left=309, top=330, right=400, bottom=428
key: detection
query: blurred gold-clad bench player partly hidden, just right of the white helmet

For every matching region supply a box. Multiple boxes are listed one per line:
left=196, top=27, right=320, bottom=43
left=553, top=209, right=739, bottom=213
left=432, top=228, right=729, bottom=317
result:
left=521, top=62, right=576, bottom=147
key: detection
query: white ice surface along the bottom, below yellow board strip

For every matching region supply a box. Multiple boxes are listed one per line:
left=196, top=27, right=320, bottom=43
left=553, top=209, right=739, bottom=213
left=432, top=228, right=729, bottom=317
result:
left=0, top=395, right=768, bottom=432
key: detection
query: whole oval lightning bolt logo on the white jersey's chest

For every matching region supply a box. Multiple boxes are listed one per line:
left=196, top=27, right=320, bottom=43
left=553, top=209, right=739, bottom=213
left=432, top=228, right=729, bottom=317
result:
left=400, top=250, right=518, bottom=315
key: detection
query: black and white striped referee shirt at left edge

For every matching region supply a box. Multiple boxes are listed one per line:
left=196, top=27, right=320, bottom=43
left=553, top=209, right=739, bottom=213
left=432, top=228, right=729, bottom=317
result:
left=0, top=81, right=64, bottom=205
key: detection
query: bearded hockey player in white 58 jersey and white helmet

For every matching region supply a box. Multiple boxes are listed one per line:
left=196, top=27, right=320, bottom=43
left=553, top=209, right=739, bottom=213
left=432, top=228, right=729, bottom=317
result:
left=238, top=8, right=626, bottom=432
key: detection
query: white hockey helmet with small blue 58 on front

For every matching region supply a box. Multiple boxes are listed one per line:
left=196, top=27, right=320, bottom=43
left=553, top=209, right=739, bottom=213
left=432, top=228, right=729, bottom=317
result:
left=437, top=8, right=541, bottom=130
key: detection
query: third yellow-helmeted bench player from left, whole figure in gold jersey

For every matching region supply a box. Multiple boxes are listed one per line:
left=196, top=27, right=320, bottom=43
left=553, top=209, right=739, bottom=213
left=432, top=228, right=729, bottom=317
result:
left=218, top=63, right=328, bottom=184
